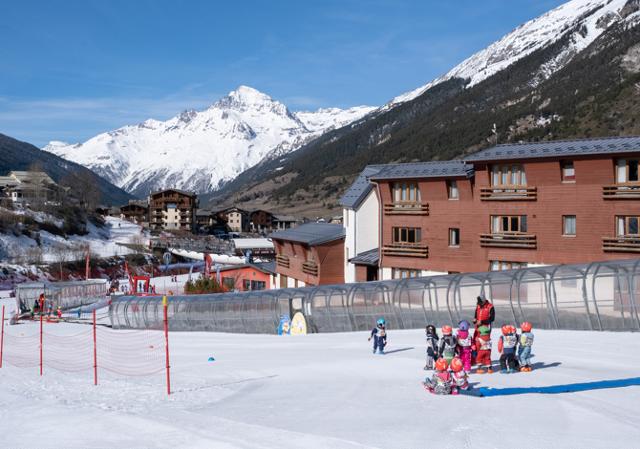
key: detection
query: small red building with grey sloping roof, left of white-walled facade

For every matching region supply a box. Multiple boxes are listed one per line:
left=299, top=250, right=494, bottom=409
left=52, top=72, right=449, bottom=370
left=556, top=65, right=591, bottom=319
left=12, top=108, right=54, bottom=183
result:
left=269, top=223, right=345, bottom=288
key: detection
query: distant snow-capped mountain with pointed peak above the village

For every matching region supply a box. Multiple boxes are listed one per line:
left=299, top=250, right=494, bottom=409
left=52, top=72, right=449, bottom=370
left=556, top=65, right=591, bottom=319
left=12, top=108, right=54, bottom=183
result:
left=43, top=86, right=375, bottom=196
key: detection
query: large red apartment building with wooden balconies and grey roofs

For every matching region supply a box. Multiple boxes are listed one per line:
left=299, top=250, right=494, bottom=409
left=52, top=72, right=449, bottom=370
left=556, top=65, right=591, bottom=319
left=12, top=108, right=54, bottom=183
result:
left=357, top=137, right=640, bottom=280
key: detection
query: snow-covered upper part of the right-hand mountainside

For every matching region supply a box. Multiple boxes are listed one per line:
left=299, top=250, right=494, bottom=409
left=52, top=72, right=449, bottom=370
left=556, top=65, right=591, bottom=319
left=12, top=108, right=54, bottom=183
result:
left=385, top=0, right=638, bottom=108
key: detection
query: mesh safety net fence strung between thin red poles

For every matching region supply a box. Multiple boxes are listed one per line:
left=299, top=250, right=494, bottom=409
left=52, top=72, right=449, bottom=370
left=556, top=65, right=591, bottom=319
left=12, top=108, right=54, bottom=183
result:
left=0, top=301, right=171, bottom=394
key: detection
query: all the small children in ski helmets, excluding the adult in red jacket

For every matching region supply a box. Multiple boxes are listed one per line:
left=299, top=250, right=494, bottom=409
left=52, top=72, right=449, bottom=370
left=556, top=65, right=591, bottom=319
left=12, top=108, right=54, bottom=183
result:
left=369, top=318, right=533, bottom=394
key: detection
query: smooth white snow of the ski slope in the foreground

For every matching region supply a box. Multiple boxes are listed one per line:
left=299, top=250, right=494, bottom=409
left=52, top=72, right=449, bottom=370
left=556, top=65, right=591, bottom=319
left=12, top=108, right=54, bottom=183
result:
left=0, top=318, right=640, bottom=449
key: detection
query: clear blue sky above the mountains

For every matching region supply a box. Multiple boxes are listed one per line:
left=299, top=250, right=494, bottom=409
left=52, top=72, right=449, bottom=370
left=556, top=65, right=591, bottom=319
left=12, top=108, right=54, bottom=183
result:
left=0, top=0, right=563, bottom=146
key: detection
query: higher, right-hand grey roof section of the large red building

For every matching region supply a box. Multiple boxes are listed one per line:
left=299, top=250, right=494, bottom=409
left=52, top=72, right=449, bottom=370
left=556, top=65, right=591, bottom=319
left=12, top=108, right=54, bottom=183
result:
left=465, top=136, right=640, bottom=162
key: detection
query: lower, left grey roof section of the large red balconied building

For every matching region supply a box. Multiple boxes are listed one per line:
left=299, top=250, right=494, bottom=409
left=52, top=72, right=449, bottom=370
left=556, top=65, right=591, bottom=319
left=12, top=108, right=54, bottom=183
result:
left=369, top=160, right=473, bottom=181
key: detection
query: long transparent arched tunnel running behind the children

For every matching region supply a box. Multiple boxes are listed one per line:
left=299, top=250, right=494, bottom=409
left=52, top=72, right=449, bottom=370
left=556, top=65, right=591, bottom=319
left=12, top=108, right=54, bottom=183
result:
left=109, top=259, right=640, bottom=333
